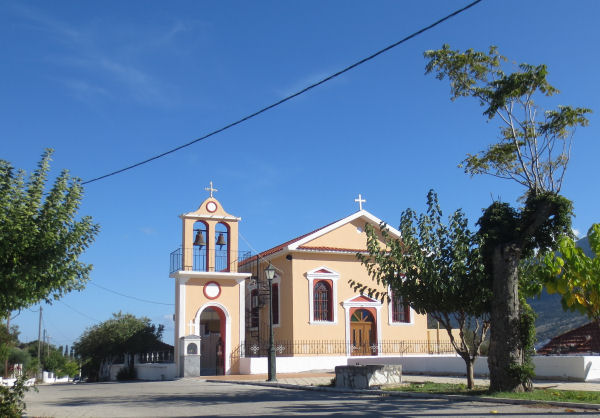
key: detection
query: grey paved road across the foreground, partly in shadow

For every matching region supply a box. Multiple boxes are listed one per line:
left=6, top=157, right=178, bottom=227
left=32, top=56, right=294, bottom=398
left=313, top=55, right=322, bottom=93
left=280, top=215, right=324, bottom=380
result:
left=26, top=379, right=598, bottom=418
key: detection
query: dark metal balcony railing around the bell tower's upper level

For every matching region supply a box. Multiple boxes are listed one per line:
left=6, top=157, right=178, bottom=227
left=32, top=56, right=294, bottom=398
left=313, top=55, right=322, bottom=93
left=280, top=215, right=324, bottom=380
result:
left=169, top=247, right=251, bottom=273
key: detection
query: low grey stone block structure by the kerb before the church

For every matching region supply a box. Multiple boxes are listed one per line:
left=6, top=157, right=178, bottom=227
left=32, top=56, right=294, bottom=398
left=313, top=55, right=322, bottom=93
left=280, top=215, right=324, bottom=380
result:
left=335, top=364, right=402, bottom=389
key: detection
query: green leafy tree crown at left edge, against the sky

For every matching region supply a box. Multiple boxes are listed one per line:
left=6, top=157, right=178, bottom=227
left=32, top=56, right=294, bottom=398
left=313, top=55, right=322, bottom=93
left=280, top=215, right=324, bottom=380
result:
left=0, top=150, right=99, bottom=315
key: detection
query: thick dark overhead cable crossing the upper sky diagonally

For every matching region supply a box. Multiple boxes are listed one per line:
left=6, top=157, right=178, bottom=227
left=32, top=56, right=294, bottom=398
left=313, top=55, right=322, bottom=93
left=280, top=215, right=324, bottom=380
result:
left=82, top=0, right=483, bottom=184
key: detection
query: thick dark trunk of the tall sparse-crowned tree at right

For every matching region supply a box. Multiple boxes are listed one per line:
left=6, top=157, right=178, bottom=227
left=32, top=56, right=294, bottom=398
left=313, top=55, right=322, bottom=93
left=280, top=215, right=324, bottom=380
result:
left=488, top=243, right=524, bottom=392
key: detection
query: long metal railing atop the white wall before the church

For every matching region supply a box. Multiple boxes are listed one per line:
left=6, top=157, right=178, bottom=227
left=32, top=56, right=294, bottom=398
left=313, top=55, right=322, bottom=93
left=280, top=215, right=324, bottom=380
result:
left=233, top=340, right=455, bottom=357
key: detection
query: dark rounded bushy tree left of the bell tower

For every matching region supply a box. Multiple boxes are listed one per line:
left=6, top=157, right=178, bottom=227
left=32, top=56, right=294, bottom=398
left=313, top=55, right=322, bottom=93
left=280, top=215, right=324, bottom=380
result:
left=73, top=312, right=164, bottom=380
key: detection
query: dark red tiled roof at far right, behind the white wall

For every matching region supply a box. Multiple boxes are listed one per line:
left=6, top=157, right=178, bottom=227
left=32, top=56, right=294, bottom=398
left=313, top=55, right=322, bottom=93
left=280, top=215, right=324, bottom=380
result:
left=537, top=322, right=600, bottom=355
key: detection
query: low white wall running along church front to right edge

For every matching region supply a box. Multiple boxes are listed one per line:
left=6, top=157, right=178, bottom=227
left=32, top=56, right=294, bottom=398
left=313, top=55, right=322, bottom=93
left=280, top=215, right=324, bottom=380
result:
left=240, top=355, right=600, bottom=382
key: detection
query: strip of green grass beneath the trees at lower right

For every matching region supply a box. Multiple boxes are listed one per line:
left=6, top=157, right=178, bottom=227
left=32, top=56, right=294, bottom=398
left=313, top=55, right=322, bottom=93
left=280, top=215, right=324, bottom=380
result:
left=387, top=382, right=600, bottom=404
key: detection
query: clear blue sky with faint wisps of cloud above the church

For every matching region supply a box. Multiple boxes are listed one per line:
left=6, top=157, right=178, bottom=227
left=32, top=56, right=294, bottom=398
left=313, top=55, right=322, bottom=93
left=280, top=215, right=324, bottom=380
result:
left=0, top=0, right=600, bottom=345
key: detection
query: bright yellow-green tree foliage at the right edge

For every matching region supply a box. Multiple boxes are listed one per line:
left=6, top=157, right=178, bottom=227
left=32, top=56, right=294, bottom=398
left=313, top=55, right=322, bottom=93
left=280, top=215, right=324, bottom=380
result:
left=536, top=224, right=600, bottom=342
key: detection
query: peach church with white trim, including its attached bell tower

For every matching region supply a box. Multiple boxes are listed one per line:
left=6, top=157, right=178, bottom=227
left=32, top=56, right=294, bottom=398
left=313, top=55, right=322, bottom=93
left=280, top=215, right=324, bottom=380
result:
left=170, top=182, right=453, bottom=376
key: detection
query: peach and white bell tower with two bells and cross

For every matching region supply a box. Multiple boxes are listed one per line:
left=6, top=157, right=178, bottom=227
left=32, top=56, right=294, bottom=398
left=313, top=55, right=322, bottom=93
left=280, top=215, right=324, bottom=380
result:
left=170, top=181, right=250, bottom=376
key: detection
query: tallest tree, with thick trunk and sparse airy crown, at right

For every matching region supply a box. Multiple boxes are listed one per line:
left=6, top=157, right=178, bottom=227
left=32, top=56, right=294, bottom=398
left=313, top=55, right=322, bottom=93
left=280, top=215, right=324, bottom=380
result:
left=424, top=45, right=591, bottom=391
